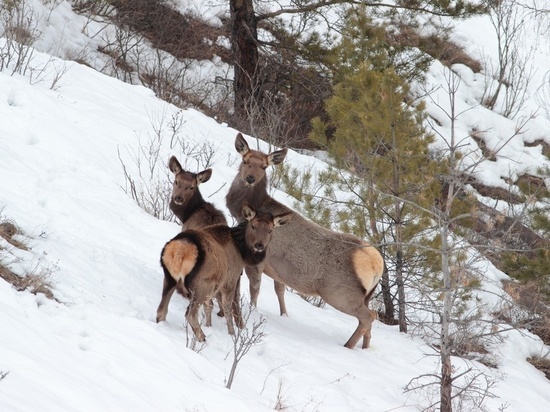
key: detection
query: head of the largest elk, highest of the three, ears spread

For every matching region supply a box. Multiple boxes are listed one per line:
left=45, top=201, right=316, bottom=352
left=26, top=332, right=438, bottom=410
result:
left=235, top=133, right=287, bottom=186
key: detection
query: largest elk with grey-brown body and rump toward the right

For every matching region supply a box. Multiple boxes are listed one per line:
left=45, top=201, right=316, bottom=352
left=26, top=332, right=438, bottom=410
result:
left=226, top=133, right=384, bottom=349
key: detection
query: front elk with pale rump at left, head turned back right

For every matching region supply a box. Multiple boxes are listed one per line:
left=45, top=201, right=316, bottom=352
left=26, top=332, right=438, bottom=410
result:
left=157, top=205, right=291, bottom=342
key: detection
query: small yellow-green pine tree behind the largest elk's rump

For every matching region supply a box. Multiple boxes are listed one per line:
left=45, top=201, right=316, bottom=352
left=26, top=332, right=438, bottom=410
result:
left=311, top=50, right=441, bottom=332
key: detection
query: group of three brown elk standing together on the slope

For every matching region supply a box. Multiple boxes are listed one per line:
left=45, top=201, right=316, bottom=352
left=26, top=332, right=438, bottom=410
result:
left=157, top=133, right=384, bottom=349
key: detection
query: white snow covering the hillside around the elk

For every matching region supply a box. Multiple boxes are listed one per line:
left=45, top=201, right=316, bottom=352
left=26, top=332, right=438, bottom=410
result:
left=0, top=2, right=550, bottom=412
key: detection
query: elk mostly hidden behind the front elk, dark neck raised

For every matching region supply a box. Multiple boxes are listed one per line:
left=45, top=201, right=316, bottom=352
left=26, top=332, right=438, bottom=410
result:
left=161, top=156, right=230, bottom=326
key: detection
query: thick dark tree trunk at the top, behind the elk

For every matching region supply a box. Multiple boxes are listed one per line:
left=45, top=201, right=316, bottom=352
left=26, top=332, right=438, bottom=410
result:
left=229, top=0, right=260, bottom=119
